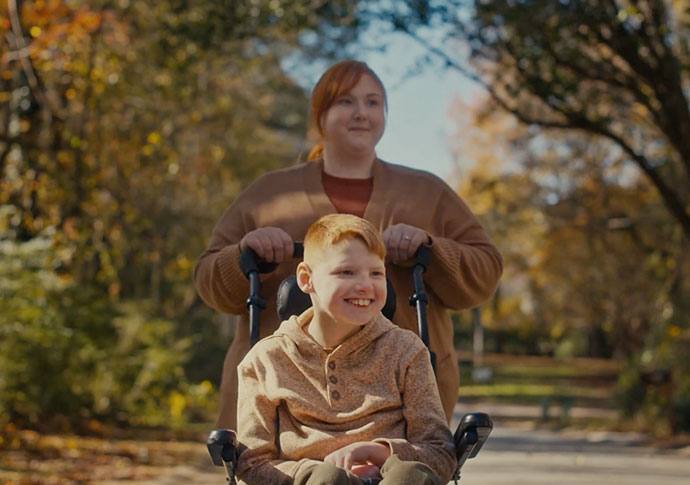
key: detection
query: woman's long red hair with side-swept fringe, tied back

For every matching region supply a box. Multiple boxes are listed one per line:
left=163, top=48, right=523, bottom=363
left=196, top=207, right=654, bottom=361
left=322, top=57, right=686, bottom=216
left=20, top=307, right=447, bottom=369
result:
left=307, top=60, right=387, bottom=160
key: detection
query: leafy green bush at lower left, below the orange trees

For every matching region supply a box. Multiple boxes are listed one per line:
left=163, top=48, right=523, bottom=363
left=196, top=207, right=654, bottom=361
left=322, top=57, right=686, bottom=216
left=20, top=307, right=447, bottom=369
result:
left=0, top=228, right=215, bottom=425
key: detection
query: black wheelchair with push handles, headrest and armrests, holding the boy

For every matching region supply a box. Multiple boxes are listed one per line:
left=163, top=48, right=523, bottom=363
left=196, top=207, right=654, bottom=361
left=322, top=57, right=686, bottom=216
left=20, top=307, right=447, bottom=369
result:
left=206, top=242, right=493, bottom=485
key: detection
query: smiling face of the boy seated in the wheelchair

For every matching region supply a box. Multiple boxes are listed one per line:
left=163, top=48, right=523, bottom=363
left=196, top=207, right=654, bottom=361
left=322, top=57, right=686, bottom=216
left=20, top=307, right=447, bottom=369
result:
left=297, top=239, right=386, bottom=326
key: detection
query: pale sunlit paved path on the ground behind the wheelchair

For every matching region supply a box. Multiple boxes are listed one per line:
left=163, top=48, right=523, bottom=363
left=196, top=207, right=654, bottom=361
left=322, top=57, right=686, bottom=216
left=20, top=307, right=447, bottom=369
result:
left=141, top=405, right=690, bottom=485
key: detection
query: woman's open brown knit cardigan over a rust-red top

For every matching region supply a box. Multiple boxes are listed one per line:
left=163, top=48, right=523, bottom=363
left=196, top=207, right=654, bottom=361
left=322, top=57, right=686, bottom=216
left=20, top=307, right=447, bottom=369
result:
left=194, top=160, right=502, bottom=428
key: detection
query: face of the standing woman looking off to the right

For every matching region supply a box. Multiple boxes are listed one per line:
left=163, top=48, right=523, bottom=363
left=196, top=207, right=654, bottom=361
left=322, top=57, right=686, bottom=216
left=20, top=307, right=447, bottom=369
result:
left=321, top=74, right=386, bottom=154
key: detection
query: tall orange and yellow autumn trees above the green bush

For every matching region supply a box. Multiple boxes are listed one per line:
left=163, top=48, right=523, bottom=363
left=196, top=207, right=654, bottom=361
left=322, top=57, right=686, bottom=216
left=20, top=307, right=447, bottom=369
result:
left=0, top=1, right=368, bottom=288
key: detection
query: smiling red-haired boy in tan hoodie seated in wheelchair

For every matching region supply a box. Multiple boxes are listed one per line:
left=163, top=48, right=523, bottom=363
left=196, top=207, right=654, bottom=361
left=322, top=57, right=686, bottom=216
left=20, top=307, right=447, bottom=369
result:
left=237, top=214, right=456, bottom=485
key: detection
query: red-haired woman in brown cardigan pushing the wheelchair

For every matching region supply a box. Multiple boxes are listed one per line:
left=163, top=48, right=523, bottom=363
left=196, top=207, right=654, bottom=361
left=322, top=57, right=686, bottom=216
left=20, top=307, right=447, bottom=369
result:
left=194, top=60, right=502, bottom=428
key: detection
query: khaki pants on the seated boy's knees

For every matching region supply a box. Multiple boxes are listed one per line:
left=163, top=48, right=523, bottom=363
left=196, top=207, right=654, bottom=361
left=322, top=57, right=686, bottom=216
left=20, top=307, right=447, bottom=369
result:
left=294, top=455, right=443, bottom=485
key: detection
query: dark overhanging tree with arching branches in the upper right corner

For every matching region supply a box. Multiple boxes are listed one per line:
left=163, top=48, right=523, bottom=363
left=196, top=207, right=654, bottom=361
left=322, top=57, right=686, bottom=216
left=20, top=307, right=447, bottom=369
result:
left=394, top=0, right=690, bottom=238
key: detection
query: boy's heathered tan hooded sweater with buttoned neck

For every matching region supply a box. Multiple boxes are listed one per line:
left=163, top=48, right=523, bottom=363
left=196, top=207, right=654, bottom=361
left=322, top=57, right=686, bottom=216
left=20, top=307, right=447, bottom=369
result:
left=238, top=309, right=456, bottom=484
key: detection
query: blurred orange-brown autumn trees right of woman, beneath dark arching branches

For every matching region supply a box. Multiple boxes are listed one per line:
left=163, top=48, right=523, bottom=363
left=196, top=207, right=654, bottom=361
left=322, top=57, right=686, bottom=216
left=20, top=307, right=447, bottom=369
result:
left=452, top=93, right=690, bottom=429
